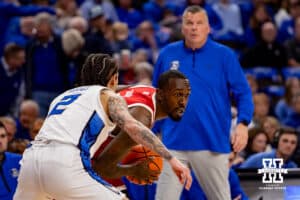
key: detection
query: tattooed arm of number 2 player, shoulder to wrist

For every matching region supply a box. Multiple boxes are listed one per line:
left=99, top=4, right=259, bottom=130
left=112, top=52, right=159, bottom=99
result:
left=108, top=95, right=172, bottom=160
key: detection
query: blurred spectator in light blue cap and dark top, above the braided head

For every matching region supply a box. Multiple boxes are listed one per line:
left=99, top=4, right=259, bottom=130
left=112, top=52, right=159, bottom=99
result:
left=84, top=6, right=113, bottom=56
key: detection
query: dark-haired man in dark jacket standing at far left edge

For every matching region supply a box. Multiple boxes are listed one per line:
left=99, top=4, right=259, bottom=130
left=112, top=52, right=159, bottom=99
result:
left=0, top=43, right=25, bottom=116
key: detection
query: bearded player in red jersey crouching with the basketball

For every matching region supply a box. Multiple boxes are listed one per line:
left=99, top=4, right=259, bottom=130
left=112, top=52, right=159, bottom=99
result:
left=95, top=70, right=190, bottom=183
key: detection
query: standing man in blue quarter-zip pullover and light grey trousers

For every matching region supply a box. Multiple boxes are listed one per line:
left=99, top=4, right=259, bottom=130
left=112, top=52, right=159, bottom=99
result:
left=153, top=6, right=253, bottom=200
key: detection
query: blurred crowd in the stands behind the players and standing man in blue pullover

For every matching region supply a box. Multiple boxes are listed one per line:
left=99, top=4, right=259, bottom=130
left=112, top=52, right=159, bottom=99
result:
left=0, top=0, right=300, bottom=199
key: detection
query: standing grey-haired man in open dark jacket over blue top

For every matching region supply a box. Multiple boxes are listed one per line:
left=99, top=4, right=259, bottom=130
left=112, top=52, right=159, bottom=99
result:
left=26, top=13, right=69, bottom=116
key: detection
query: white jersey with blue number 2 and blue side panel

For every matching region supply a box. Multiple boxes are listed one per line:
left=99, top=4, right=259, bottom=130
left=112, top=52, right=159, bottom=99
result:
left=33, top=86, right=115, bottom=158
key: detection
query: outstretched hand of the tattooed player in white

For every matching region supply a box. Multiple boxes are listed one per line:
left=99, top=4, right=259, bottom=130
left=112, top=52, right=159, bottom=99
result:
left=169, top=157, right=193, bottom=190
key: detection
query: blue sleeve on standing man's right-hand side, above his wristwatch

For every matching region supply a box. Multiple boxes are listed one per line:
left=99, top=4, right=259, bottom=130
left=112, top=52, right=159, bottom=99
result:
left=224, top=50, right=254, bottom=123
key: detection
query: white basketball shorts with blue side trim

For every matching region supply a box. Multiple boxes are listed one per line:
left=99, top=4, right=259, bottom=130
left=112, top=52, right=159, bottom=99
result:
left=14, top=142, right=126, bottom=200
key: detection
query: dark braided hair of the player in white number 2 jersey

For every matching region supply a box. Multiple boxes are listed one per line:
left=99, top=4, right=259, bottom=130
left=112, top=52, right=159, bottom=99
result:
left=80, top=53, right=118, bottom=86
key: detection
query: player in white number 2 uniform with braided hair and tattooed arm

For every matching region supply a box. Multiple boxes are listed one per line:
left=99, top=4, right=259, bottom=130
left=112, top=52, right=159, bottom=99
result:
left=14, top=54, right=192, bottom=200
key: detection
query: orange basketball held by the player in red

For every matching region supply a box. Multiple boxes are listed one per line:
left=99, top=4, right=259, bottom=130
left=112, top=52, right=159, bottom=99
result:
left=122, top=145, right=163, bottom=185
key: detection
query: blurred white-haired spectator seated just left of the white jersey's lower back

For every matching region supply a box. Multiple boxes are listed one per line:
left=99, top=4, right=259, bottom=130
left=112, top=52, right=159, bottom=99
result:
left=15, top=100, right=39, bottom=140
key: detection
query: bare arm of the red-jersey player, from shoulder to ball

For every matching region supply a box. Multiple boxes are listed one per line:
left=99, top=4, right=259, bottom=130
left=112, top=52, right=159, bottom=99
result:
left=93, top=106, right=151, bottom=180
